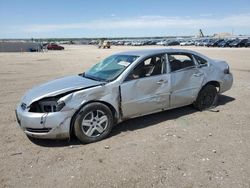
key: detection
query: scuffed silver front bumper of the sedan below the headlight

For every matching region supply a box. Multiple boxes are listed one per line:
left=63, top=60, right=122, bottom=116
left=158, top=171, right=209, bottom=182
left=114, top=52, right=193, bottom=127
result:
left=16, top=105, right=74, bottom=139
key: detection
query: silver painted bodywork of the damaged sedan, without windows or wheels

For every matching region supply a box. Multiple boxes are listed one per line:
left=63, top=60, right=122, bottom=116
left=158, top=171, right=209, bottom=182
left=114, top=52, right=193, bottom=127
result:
left=16, top=49, right=233, bottom=138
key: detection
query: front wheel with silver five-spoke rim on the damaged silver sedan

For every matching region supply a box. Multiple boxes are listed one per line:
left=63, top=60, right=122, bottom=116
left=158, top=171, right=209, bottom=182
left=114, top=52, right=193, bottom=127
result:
left=74, top=102, right=114, bottom=144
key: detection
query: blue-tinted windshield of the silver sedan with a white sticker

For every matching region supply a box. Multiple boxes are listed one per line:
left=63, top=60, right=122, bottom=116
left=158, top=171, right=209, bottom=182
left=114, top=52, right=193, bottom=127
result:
left=84, top=55, right=139, bottom=81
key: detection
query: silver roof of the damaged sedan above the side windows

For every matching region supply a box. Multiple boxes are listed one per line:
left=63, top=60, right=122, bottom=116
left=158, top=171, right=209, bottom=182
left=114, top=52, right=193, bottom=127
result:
left=117, top=48, right=197, bottom=57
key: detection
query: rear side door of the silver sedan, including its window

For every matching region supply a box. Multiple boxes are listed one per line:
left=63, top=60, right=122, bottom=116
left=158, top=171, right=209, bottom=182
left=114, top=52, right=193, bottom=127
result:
left=168, top=53, right=204, bottom=108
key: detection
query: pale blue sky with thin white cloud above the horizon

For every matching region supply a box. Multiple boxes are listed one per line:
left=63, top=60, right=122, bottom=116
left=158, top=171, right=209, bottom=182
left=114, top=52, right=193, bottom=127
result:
left=0, top=0, right=250, bottom=39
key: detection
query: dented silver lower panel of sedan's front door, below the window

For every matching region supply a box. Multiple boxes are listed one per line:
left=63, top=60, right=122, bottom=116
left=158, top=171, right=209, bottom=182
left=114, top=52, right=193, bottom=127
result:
left=121, top=74, right=170, bottom=118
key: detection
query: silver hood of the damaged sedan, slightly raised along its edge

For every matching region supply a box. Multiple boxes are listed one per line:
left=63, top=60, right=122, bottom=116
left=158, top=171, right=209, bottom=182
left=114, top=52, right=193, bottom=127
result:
left=22, top=75, right=102, bottom=106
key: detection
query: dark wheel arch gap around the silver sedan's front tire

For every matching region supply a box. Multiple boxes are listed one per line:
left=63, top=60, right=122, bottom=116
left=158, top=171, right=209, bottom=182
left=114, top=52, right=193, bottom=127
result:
left=69, top=100, right=118, bottom=138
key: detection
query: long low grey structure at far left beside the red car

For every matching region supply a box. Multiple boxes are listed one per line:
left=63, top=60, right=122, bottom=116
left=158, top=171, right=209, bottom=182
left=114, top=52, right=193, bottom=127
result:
left=0, top=41, right=42, bottom=52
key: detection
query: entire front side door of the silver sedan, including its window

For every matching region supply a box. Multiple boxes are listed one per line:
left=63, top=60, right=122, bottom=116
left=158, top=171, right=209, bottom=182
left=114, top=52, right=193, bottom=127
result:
left=121, top=54, right=170, bottom=118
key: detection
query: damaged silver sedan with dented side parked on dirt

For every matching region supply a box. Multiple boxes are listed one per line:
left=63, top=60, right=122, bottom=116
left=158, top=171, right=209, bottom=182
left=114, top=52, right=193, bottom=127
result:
left=16, top=49, right=233, bottom=143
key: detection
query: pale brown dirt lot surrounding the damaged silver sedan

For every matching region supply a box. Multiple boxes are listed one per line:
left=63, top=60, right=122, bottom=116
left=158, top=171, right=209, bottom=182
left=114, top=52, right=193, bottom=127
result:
left=0, top=46, right=250, bottom=188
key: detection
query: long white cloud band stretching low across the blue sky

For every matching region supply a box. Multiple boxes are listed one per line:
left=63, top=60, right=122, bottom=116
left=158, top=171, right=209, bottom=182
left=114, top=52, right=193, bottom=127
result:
left=23, top=14, right=250, bottom=33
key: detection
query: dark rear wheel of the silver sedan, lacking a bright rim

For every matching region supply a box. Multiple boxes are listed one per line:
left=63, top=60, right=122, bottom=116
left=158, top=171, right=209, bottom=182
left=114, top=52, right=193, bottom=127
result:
left=193, top=84, right=218, bottom=111
